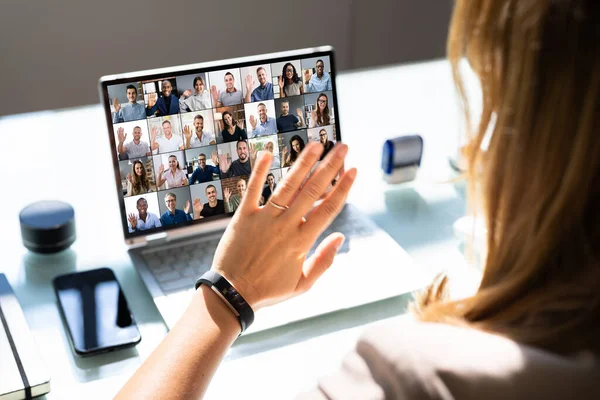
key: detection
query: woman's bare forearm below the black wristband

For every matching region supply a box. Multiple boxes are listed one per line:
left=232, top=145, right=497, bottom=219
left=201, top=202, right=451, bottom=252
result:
left=116, top=285, right=241, bottom=399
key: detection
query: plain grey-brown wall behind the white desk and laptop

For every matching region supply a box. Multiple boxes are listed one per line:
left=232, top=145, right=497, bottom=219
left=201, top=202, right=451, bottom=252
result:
left=0, top=0, right=451, bottom=115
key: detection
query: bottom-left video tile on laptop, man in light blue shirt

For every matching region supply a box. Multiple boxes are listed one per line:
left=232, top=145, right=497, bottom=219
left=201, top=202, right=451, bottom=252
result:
left=124, top=193, right=162, bottom=233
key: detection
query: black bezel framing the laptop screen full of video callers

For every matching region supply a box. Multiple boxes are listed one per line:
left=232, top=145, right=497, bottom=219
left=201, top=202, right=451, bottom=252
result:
left=99, top=46, right=341, bottom=245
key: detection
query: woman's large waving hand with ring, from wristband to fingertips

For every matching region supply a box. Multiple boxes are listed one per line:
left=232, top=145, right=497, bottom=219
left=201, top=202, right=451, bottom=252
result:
left=212, top=143, right=356, bottom=310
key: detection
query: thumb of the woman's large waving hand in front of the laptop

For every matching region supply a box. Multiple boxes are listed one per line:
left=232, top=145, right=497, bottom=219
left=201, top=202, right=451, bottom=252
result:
left=295, top=232, right=344, bottom=294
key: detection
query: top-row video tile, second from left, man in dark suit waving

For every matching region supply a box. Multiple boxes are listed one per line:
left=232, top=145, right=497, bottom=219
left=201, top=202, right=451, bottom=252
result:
left=142, top=77, right=179, bottom=117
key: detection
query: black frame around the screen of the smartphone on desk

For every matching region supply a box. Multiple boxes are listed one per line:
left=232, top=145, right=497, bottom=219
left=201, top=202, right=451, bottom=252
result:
left=52, top=268, right=142, bottom=356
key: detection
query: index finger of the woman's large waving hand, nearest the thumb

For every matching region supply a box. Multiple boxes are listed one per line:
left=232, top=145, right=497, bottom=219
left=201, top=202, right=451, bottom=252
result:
left=300, top=168, right=356, bottom=238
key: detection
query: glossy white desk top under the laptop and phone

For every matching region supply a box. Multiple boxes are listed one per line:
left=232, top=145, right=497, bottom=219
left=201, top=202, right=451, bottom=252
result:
left=0, top=57, right=478, bottom=399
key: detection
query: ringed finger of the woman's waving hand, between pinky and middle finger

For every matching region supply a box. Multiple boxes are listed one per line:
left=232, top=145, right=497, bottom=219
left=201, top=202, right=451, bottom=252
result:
left=272, top=142, right=323, bottom=209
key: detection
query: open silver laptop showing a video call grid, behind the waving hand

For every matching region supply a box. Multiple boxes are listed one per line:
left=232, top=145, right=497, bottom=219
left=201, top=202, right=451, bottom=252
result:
left=99, top=47, right=428, bottom=334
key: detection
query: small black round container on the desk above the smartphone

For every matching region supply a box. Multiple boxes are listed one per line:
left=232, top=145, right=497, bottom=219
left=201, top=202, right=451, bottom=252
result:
left=19, top=200, right=76, bottom=253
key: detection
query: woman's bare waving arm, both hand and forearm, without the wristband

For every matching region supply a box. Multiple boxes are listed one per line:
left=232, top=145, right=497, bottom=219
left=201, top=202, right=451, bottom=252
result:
left=117, top=142, right=356, bottom=399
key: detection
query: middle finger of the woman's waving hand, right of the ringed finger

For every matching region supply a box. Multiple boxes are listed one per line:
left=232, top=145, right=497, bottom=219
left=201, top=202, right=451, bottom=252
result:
left=287, top=142, right=348, bottom=218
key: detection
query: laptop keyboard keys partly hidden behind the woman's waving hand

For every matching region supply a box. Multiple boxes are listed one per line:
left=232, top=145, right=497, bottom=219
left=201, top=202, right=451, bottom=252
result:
left=141, top=205, right=374, bottom=295
